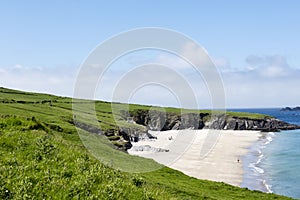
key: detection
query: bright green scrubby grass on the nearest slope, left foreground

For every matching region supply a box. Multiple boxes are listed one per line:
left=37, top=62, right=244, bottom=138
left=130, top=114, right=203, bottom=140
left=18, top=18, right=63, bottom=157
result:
left=0, top=117, right=171, bottom=199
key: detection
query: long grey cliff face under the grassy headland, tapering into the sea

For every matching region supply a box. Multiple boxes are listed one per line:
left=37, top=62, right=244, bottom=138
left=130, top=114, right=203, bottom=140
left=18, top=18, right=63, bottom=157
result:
left=122, top=110, right=300, bottom=132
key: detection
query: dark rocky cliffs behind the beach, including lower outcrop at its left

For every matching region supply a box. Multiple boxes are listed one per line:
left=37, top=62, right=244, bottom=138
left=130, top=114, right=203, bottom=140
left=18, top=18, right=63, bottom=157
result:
left=104, top=109, right=300, bottom=151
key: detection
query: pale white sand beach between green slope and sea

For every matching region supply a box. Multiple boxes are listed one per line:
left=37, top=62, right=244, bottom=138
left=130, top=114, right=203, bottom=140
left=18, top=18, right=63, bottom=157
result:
left=128, top=130, right=261, bottom=186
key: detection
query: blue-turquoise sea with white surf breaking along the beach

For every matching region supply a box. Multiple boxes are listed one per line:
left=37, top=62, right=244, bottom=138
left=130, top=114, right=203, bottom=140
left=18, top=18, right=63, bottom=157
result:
left=229, top=108, right=300, bottom=199
